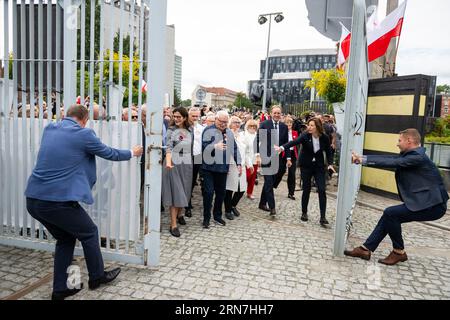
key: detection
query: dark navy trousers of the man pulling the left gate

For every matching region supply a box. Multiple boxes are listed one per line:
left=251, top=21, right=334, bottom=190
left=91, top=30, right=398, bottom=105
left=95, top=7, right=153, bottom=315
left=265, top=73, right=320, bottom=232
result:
left=27, top=198, right=104, bottom=291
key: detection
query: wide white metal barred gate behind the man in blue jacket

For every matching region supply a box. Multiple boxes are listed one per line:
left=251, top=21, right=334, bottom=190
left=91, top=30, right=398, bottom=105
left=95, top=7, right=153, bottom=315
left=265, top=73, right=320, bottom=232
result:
left=0, top=0, right=167, bottom=265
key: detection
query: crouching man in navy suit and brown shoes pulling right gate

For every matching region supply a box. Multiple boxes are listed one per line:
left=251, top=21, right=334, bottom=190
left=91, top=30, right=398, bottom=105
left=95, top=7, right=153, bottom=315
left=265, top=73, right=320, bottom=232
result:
left=344, top=129, right=449, bottom=265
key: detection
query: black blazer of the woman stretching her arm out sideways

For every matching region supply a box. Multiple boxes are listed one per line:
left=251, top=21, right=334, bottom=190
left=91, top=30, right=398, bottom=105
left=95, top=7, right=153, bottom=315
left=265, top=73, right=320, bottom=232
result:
left=283, top=133, right=331, bottom=167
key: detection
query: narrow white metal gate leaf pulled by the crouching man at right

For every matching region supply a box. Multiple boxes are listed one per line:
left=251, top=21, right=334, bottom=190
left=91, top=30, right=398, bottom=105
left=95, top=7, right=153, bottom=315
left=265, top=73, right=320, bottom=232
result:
left=333, top=0, right=369, bottom=256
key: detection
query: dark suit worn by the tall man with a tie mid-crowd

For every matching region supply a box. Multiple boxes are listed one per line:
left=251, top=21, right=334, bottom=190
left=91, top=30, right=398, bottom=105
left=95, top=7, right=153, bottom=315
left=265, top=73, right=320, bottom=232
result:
left=256, top=120, right=291, bottom=209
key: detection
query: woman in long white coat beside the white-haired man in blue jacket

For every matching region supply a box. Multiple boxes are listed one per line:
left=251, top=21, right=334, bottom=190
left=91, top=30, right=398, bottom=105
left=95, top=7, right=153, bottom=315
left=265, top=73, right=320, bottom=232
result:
left=224, top=116, right=253, bottom=220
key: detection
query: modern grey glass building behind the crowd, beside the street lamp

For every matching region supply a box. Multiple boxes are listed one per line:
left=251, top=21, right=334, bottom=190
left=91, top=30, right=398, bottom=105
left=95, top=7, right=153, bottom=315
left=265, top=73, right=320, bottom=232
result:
left=248, top=49, right=336, bottom=106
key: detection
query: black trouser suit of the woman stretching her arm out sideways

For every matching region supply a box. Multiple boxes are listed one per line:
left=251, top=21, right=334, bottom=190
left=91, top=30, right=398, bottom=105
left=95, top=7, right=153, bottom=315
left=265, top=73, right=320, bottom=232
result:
left=283, top=133, right=331, bottom=219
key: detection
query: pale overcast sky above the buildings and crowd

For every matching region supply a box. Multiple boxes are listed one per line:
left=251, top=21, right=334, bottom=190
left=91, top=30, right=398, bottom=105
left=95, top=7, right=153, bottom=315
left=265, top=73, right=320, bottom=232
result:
left=0, top=0, right=450, bottom=99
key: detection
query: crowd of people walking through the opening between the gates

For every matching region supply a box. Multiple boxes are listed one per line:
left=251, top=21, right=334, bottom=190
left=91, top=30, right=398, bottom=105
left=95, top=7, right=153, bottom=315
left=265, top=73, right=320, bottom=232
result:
left=158, top=106, right=338, bottom=237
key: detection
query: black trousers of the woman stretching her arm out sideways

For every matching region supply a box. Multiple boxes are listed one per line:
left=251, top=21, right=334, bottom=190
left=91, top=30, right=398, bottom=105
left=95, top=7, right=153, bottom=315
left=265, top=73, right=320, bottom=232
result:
left=301, top=164, right=327, bottom=218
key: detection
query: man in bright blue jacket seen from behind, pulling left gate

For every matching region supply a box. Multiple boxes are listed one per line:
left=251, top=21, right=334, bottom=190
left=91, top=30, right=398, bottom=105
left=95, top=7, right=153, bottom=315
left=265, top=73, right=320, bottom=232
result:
left=25, top=105, right=143, bottom=300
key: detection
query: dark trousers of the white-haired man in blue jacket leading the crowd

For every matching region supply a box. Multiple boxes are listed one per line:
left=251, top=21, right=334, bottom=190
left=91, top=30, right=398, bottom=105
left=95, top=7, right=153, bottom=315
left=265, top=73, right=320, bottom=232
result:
left=202, top=170, right=227, bottom=223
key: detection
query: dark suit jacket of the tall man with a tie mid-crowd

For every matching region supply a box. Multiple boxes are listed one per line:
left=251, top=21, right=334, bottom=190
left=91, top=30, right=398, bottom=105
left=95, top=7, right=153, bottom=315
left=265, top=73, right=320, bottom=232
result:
left=255, top=120, right=291, bottom=167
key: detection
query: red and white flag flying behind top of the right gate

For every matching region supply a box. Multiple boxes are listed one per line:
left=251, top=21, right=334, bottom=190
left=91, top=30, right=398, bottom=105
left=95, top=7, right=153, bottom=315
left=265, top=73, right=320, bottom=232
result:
left=338, top=0, right=407, bottom=68
